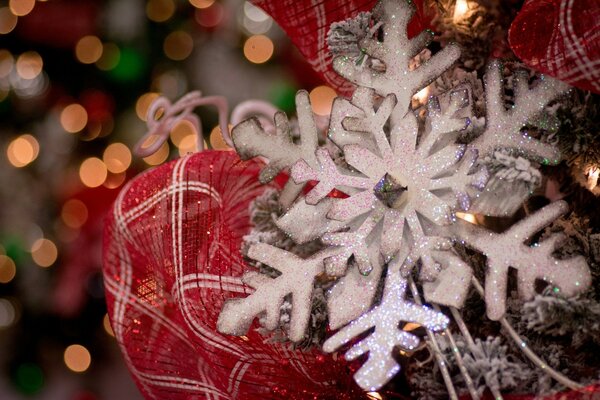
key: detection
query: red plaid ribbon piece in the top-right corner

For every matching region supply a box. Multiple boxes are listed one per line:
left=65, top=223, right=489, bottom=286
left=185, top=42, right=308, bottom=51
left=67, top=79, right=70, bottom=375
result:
left=509, top=0, right=600, bottom=93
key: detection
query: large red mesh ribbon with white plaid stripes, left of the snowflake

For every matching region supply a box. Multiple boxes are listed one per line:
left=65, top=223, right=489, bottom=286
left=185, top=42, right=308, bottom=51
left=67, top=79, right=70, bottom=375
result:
left=104, top=151, right=363, bottom=400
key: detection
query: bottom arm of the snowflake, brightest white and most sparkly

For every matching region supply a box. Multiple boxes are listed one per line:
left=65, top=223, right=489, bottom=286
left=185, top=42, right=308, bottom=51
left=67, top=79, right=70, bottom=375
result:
left=323, top=271, right=449, bottom=390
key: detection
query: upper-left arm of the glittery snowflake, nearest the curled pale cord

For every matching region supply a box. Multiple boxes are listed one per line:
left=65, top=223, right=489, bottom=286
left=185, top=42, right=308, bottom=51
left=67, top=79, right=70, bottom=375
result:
left=232, top=90, right=318, bottom=183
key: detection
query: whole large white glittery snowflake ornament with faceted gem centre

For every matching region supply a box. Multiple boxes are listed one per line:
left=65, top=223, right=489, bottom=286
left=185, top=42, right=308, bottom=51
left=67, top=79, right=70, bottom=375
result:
left=217, top=0, right=590, bottom=390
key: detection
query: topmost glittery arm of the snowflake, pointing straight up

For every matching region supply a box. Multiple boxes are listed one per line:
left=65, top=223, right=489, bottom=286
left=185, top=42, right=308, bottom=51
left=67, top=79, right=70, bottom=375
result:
left=333, top=0, right=460, bottom=110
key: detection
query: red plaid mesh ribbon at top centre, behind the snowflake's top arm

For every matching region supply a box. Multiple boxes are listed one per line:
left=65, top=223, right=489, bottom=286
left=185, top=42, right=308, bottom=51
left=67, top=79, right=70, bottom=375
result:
left=252, top=0, right=430, bottom=95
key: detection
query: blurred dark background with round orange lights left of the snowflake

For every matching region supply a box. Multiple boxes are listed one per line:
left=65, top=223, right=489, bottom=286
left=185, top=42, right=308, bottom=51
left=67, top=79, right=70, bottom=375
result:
left=0, top=0, right=335, bottom=400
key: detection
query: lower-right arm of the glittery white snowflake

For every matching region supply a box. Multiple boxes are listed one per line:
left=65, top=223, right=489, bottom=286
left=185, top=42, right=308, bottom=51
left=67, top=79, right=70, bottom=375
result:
left=456, top=201, right=591, bottom=320
